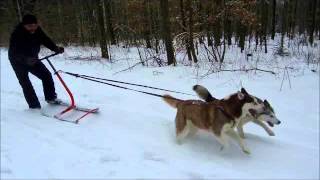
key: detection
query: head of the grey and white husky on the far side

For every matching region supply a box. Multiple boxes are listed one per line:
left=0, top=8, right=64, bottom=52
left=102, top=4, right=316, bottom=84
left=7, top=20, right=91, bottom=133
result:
left=249, top=100, right=281, bottom=127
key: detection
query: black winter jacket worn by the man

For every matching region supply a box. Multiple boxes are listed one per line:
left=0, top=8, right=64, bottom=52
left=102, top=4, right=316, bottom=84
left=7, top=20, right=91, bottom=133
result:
left=8, top=23, right=58, bottom=64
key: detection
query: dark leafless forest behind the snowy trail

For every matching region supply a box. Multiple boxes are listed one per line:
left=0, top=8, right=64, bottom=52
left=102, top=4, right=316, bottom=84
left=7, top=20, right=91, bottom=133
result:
left=0, top=0, right=320, bottom=65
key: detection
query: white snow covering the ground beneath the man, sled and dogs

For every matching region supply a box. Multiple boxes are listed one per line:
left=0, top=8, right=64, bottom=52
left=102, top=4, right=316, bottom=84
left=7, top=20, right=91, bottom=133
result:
left=0, top=47, right=319, bottom=179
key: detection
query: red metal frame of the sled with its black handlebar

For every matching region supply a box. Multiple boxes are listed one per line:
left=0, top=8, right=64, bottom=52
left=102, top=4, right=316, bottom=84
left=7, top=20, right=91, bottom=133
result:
left=39, top=53, right=99, bottom=124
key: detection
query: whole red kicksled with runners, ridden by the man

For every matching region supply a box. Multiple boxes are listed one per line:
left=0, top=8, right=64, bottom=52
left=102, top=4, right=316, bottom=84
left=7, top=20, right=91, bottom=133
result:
left=39, top=53, right=99, bottom=124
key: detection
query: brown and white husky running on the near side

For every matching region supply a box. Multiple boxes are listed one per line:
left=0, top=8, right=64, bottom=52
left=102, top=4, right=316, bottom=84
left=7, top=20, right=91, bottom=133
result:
left=163, top=89, right=263, bottom=154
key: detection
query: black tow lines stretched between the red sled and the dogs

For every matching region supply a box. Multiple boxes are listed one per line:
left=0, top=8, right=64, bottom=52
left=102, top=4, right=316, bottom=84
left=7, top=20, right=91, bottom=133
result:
left=59, top=70, right=195, bottom=99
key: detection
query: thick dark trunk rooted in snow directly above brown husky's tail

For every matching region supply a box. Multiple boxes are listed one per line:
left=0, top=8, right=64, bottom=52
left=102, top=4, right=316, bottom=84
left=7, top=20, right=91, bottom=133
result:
left=160, top=0, right=176, bottom=65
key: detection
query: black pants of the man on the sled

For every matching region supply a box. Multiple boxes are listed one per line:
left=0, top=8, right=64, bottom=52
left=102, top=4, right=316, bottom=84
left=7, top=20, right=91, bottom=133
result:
left=10, top=61, right=57, bottom=108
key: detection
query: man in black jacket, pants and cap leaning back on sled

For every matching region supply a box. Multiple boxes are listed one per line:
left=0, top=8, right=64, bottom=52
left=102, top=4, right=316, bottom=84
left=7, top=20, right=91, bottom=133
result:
left=8, top=14, right=64, bottom=109
